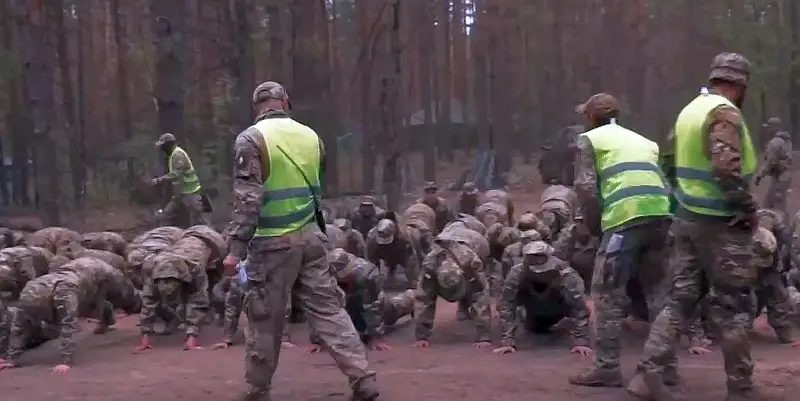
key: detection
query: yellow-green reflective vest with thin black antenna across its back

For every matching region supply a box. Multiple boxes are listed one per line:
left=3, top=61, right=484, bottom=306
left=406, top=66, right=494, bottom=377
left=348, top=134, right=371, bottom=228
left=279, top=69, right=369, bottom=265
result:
left=255, top=118, right=321, bottom=237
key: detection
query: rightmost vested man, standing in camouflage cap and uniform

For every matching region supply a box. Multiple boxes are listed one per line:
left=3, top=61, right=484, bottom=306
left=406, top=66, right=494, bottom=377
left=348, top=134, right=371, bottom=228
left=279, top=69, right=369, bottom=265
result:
left=627, top=53, right=771, bottom=401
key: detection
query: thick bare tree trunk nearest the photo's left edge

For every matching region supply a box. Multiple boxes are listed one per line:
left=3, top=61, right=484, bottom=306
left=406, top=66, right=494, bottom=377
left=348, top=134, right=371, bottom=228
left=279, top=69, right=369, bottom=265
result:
left=13, top=0, right=61, bottom=226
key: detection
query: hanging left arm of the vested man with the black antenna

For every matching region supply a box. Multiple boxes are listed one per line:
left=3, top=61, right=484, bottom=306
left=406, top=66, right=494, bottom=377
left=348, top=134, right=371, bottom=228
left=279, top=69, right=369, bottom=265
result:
left=228, top=127, right=269, bottom=258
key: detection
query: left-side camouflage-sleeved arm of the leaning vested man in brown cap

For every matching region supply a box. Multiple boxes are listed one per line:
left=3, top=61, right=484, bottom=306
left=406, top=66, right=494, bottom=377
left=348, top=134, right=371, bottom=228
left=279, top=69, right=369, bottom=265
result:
left=575, top=136, right=602, bottom=235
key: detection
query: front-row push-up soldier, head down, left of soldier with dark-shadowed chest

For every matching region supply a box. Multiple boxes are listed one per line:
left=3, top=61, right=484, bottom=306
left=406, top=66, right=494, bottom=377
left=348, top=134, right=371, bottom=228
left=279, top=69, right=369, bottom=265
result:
left=414, top=243, right=492, bottom=348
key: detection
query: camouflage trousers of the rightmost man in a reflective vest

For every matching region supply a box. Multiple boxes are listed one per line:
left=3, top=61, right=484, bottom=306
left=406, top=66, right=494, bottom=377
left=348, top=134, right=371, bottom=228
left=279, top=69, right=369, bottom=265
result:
left=637, top=218, right=756, bottom=391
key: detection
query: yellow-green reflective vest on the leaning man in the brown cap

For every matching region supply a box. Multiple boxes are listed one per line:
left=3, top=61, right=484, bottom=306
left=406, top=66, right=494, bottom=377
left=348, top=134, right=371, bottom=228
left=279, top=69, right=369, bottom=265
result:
left=582, top=124, right=670, bottom=231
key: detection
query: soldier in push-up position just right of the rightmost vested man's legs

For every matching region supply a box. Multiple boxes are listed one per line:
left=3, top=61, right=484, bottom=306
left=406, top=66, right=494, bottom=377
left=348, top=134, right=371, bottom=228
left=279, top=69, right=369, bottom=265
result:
left=750, top=226, right=793, bottom=344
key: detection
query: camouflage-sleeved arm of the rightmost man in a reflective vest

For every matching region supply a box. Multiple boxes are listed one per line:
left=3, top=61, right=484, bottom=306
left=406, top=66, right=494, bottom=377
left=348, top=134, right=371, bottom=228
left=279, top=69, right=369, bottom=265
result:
left=707, top=106, right=757, bottom=214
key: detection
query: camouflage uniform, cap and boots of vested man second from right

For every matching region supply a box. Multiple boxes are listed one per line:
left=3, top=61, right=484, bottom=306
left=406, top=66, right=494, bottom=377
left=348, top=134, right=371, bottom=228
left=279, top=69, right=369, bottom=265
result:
left=569, top=94, right=677, bottom=387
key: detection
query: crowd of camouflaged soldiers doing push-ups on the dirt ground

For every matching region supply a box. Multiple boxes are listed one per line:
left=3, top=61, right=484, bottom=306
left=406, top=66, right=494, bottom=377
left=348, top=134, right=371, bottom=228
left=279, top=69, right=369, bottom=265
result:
left=0, top=179, right=800, bottom=373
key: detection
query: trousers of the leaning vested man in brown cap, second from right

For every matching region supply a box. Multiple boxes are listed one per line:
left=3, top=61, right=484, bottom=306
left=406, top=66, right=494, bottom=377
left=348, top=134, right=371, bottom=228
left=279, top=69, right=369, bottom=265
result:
left=591, top=220, right=677, bottom=370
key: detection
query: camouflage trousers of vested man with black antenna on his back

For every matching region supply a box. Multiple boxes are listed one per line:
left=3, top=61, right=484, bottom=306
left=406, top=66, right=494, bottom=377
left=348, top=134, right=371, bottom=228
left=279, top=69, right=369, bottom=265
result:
left=244, top=223, right=375, bottom=390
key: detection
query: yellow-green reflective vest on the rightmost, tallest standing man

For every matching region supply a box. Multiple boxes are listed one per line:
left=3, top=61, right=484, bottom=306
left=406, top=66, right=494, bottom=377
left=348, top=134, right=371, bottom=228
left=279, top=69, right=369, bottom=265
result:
left=675, top=93, right=757, bottom=217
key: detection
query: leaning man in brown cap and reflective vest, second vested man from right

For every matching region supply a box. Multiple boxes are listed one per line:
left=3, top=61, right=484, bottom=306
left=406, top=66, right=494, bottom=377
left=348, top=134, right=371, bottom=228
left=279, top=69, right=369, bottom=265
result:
left=569, top=93, right=675, bottom=387
